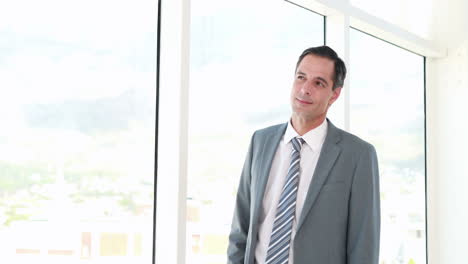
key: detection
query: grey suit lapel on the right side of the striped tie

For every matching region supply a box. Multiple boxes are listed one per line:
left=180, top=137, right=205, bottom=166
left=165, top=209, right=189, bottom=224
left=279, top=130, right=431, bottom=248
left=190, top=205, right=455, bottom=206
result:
left=296, top=119, right=341, bottom=232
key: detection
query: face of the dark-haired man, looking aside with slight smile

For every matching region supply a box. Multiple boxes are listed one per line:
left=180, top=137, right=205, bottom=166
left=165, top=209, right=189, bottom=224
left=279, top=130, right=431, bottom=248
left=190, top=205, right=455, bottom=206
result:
left=291, top=54, right=341, bottom=121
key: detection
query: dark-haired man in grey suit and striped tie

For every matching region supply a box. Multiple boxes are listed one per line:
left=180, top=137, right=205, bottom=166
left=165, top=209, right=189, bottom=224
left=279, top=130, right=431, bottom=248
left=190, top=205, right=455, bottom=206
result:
left=228, top=46, right=380, bottom=264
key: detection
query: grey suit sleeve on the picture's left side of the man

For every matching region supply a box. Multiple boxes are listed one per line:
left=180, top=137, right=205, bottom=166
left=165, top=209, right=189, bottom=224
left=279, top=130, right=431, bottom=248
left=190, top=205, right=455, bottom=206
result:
left=227, top=133, right=254, bottom=264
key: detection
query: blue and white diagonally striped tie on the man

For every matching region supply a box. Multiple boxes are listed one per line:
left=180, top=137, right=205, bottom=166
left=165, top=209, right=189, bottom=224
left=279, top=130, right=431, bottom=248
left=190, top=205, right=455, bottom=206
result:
left=265, top=137, right=304, bottom=264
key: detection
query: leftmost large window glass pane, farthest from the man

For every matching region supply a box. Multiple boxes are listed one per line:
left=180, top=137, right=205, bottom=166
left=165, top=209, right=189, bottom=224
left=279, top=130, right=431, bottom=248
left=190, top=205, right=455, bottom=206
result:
left=0, top=0, right=157, bottom=263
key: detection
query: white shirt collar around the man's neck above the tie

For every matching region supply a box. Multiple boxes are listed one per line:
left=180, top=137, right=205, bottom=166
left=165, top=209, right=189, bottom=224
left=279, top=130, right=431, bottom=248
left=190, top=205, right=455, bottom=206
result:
left=284, top=119, right=328, bottom=152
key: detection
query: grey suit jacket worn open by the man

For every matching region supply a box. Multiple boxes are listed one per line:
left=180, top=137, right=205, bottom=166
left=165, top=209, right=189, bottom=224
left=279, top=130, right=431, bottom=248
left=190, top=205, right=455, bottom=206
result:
left=228, top=121, right=380, bottom=264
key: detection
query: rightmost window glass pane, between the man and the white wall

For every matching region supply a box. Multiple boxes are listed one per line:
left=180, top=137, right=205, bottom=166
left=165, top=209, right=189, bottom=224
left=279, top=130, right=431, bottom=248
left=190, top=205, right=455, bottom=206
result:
left=349, top=30, right=426, bottom=263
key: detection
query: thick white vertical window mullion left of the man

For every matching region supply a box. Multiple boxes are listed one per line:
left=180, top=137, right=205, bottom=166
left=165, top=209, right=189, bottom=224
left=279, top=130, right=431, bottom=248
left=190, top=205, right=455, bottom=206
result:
left=155, top=0, right=190, bottom=264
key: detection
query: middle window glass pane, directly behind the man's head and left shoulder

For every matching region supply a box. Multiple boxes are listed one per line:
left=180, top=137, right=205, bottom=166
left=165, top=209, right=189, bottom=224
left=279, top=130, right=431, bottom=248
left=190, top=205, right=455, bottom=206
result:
left=187, top=0, right=324, bottom=264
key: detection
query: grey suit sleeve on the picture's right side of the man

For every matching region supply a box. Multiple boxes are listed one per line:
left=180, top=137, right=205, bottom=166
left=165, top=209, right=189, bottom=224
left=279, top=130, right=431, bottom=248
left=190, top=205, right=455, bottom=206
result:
left=347, top=145, right=380, bottom=264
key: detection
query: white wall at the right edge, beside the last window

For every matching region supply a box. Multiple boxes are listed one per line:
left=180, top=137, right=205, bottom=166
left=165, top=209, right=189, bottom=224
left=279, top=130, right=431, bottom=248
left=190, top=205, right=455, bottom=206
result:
left=427, top=0, right=468, bottom=264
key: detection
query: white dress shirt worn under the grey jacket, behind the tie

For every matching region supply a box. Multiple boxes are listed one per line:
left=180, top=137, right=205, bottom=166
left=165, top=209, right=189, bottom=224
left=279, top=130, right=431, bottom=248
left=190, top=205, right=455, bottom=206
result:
left=255, top=120, right=327, bottom=264
